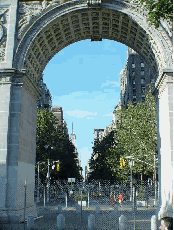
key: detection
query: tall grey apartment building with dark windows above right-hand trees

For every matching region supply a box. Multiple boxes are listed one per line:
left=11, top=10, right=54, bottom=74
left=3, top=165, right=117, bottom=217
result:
left=120, top=48, right=153, bottom=105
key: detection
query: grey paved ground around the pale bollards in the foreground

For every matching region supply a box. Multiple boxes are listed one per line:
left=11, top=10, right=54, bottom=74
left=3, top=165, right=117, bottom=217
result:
left=0, top=203, right=160, bottom=230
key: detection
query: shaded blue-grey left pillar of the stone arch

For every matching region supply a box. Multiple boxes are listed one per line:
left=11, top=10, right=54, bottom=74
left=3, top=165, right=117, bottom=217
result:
left=0, top=69, right=39, bottom=222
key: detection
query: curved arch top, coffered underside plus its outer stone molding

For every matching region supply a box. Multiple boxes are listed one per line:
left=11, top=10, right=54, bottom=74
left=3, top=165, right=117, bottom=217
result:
left=14, top=1, right=172, bottom=89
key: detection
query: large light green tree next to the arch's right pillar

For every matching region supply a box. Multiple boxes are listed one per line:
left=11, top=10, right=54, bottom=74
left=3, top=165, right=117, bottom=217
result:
left=107, top=86, right=157, bottom=179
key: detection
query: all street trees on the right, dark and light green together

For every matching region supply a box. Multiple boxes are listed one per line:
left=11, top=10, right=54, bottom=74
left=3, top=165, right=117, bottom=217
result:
left=91, top=88, right=157, bottom=180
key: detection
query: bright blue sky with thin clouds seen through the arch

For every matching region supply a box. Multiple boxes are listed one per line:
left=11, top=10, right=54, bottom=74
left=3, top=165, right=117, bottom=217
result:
left=43, top=39, right=127, bottom=179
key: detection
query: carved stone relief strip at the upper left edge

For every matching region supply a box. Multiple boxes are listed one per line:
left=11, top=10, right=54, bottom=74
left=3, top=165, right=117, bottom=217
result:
left=0, top=6, right=9, bottom=62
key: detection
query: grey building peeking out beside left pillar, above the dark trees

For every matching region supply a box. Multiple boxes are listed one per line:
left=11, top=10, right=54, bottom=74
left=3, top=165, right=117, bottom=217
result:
left=37, top=76, right=52, bottom=111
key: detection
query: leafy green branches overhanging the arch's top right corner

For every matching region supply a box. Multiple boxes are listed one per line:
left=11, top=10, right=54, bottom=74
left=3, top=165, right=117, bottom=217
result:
left=140, top=0, right=173, bottom=28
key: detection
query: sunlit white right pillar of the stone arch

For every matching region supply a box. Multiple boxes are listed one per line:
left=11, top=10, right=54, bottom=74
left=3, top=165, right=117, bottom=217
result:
left=156, top=69, right=173, bottom=219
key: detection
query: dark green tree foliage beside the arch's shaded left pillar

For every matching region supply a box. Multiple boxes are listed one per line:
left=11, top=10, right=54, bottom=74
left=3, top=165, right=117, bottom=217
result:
left=36, top=109, right=81, bottom=180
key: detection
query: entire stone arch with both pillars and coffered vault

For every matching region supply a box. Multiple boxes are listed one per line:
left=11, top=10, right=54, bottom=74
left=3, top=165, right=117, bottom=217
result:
left=0, top=0, right=173, bottom=221
